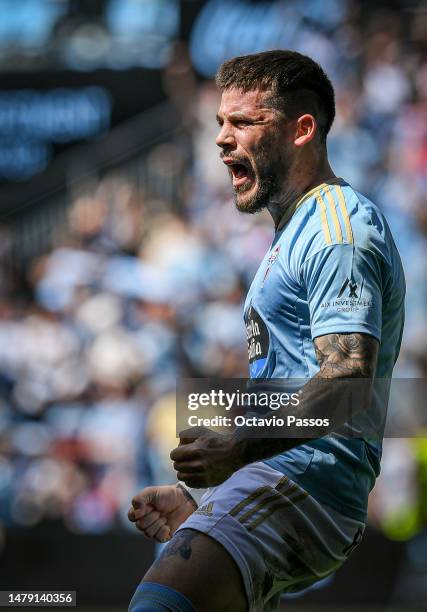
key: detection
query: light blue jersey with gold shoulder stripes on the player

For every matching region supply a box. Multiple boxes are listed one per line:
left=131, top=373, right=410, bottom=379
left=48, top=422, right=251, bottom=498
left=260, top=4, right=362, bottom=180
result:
left=245, top=179, right=405, bottom=520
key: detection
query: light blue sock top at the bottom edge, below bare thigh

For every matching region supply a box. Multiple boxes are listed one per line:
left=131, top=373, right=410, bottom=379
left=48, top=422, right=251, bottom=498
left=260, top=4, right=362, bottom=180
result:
left=128, top=582, right=197, bottom=612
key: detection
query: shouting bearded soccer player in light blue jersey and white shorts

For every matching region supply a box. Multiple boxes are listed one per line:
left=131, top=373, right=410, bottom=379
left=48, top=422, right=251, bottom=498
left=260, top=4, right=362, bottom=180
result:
left=129, top=50, right=405, bottom=612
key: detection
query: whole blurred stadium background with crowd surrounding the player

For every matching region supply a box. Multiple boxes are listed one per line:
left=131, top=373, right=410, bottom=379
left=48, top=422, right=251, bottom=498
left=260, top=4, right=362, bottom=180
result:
left=0, top=0, right=427, bottom=610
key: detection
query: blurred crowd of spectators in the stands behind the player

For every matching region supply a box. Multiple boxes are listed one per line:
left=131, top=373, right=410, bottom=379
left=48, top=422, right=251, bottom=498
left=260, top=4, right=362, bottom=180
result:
left=0, top=0, right=427, bottom=538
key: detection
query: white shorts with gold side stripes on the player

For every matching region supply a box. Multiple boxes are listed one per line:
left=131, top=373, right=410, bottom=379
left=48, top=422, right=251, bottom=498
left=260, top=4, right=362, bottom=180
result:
left=179, top=462, right=365, bottom=612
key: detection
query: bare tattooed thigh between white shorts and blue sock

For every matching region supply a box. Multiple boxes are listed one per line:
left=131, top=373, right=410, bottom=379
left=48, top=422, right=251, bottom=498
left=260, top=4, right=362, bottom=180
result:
left=143, top=529, right=248, bottom=612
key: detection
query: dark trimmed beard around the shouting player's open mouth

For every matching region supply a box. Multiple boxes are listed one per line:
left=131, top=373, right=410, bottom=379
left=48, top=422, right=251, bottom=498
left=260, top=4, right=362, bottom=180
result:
left=234, top=145, right=290, bottom=215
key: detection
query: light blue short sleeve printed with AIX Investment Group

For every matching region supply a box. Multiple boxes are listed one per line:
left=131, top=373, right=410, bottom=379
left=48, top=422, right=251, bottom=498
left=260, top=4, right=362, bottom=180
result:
left=301, top=244, right=384, bottom=340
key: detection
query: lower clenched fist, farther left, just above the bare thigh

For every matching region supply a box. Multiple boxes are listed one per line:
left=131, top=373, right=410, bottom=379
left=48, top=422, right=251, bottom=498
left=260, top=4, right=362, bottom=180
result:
left=128, top=484, right=197, bottom=543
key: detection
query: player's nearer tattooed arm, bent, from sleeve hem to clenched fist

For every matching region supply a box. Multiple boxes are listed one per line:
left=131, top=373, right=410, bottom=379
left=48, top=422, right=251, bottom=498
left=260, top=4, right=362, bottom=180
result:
left=171, top=333, right=379, bottom=488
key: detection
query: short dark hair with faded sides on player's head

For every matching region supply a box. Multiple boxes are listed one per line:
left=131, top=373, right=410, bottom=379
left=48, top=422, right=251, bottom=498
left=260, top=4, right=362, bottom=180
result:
left=216, top=49, right=335, bottom=142
